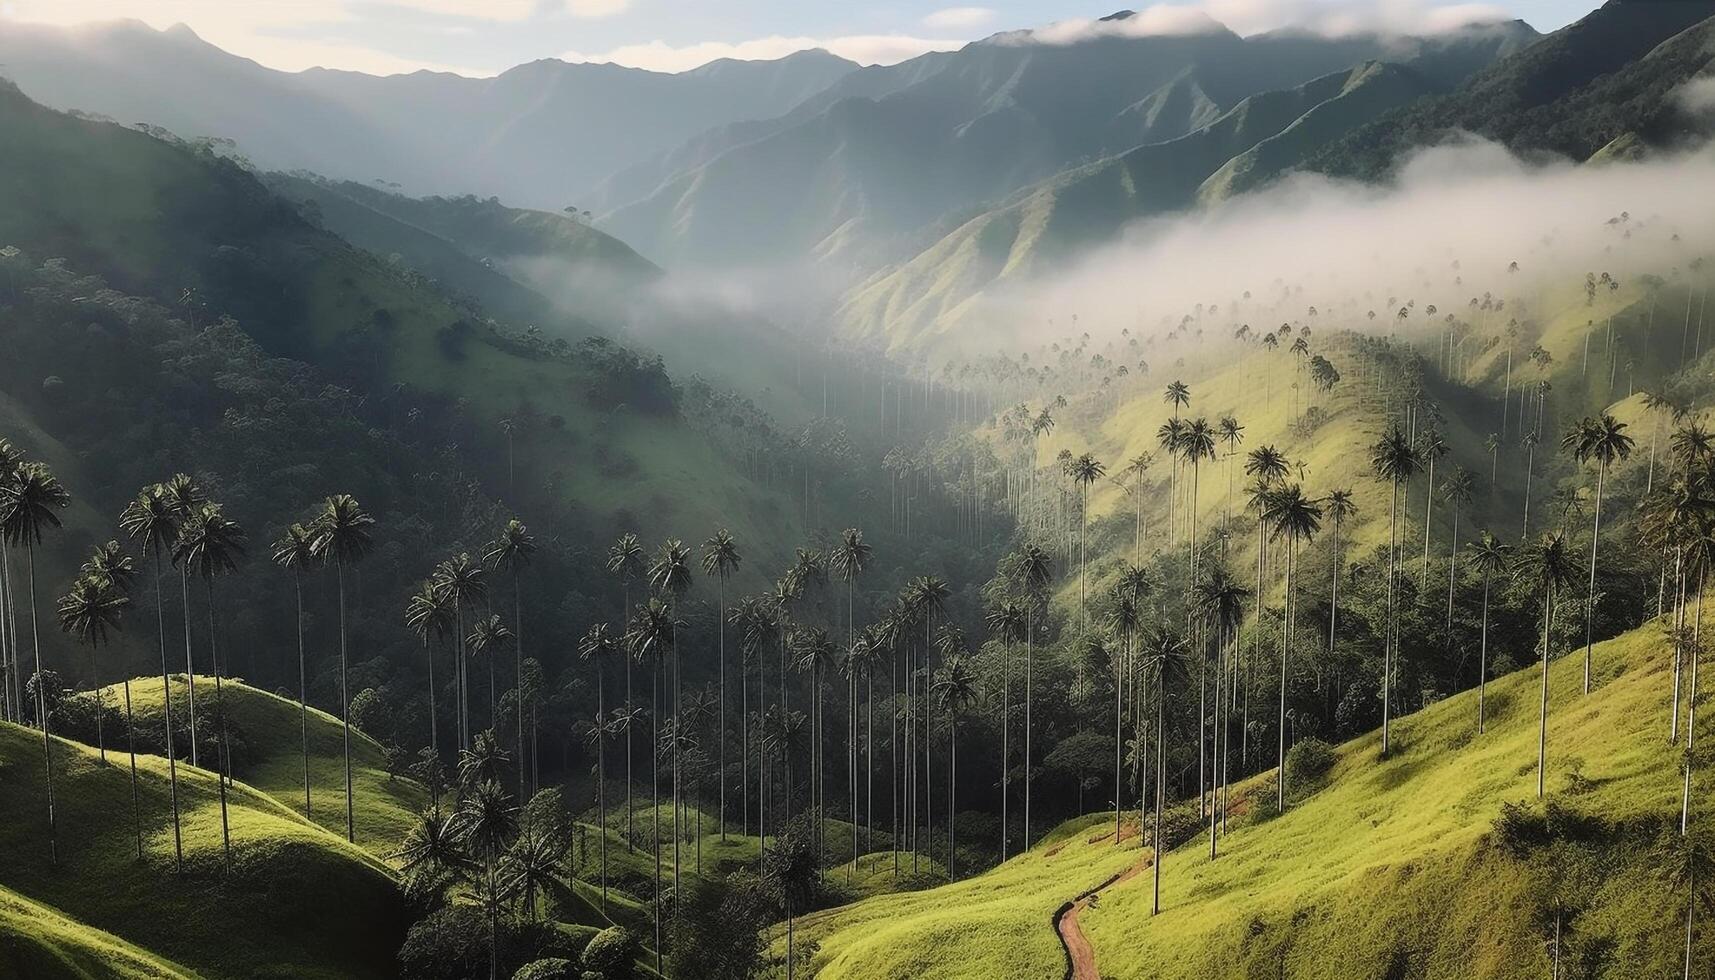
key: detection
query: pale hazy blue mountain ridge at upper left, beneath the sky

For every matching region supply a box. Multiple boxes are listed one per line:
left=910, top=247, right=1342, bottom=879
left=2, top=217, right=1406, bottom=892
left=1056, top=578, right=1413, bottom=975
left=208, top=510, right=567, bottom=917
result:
left=0, top=21, right=858, bottom=209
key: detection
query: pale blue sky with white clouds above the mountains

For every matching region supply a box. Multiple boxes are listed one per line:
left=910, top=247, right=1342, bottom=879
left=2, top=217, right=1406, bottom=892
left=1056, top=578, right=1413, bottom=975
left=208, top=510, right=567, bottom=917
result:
left=0, top=0, right=1597, bottom=76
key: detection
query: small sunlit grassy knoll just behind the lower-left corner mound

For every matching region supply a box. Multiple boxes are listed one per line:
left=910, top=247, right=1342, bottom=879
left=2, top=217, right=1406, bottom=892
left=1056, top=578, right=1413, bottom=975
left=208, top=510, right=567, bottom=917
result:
left=103, top=675, right=429, bottom=856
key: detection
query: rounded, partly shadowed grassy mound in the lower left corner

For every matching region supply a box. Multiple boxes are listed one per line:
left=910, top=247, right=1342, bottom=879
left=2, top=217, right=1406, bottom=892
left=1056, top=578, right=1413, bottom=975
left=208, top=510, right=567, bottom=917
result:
left=0, top=724, right=406, bottom=978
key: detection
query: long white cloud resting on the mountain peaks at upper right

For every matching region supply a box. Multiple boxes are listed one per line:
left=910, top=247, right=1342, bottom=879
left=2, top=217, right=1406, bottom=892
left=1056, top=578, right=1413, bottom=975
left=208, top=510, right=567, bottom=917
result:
left=1000, top=0, right=1511, bottom=45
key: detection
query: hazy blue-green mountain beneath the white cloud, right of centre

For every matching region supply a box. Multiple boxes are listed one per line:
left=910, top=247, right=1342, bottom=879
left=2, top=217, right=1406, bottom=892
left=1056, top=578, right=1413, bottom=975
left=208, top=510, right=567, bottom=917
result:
left=595, top=22, right=1537, bottom=268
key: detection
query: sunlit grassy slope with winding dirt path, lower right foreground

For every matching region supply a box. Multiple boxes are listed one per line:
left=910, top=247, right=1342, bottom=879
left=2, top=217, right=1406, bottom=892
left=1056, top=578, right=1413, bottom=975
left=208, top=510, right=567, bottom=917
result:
left=788, top=623, right=1715, bottom=980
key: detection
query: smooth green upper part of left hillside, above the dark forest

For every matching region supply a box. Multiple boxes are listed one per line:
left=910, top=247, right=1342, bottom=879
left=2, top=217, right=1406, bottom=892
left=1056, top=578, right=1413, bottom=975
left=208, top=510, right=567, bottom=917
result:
left=0, top=80, right=799, bottom=569
